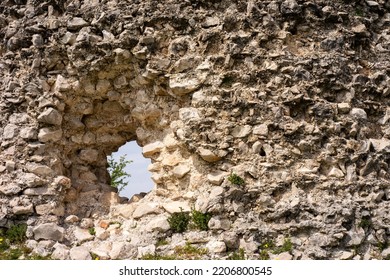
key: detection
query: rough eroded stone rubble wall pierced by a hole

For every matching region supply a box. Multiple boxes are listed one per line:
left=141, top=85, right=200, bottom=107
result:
left=0, top=0, right=390, bottom=259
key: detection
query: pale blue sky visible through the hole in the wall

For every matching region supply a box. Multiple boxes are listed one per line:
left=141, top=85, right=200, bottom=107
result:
left=112, top=141, right=154, bottom=198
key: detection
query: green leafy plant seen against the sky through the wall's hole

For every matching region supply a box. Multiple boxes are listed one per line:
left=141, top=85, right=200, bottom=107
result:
left=107, top=155, right=133, bottom=192
